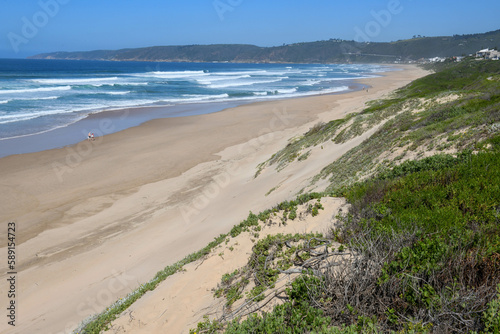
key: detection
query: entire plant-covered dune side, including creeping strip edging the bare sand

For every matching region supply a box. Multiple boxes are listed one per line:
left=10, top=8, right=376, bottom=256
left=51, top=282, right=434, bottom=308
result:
left=78, top=59, right=500, bottom=333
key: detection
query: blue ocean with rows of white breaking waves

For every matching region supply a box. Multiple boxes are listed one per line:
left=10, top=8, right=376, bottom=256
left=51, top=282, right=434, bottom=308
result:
left=0, top=59, right=391, bottom=156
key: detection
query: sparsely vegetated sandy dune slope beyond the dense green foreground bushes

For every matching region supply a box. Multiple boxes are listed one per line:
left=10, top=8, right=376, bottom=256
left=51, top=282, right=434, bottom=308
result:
left=256, top=58, right=500, bottom=191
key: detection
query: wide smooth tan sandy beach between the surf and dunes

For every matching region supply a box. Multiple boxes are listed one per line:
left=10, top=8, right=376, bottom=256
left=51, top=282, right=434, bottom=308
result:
left=0, top=66, right=427, bottom=334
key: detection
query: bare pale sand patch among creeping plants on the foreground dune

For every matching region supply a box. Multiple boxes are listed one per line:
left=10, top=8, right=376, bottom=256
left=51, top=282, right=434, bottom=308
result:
left=110, top=198, right=346, bottom=334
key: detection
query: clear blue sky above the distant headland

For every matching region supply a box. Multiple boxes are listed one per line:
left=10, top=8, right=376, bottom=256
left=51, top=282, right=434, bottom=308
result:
left=0, top=0, right=500, bottom=58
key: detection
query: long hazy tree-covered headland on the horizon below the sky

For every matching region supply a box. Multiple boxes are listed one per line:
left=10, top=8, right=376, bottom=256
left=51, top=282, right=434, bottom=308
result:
left=29, top=30, right=500, bottom=63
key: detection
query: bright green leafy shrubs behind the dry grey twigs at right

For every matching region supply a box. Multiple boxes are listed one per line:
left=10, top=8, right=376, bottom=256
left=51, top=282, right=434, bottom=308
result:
left=339, top=152, right=500, bottom=330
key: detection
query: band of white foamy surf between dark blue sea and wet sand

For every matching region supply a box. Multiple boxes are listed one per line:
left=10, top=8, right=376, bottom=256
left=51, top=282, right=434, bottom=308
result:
left=0, top=65, right=395, bottom=141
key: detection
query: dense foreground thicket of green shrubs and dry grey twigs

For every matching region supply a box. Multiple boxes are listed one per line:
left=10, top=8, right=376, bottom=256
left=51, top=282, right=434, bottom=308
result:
left=192, top=149, right=500, bottom=333
